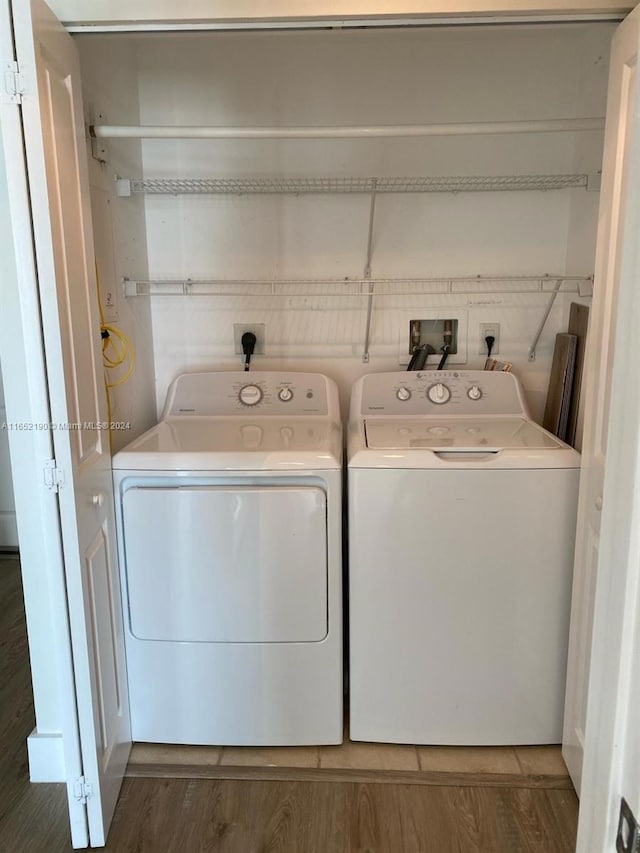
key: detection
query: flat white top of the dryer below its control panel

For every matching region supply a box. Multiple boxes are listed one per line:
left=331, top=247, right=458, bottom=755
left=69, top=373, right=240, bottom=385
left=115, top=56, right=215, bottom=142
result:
left=113, top=416, right=341, bottom=471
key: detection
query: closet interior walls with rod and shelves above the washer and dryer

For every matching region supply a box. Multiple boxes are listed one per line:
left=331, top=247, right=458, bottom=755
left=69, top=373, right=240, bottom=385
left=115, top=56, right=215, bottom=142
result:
left=77, top=23, right=614, bottom=752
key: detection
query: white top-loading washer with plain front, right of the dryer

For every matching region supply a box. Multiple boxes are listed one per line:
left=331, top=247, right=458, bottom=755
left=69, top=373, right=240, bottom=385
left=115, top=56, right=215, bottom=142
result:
left=348, top=370, right=580, bottom=745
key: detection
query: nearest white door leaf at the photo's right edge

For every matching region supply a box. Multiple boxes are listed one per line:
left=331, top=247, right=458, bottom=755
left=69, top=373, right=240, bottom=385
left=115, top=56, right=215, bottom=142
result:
left=568, top=1, right=640, bottom=853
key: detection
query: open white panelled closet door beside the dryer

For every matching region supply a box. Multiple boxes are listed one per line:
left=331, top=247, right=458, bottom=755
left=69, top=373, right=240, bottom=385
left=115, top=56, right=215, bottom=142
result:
left=13, top=0, right=130, bottom=846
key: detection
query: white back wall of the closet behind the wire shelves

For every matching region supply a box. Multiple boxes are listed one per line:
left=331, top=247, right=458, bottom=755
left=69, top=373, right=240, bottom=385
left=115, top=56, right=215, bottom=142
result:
left=81, top=25, right=613, bottom=418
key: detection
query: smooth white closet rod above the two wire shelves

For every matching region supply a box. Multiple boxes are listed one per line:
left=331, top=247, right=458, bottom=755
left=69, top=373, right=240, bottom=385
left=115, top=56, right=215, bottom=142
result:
left=89, top=118, right=604, bottom=139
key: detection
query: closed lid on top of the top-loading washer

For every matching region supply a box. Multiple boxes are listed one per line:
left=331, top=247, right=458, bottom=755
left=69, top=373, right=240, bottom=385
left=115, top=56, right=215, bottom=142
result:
left=364, top=418, right=566, bottom=453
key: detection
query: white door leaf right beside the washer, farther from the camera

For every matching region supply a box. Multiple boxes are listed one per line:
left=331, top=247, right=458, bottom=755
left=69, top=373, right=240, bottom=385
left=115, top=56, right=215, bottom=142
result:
left=563, top=0, right=640, bottom=793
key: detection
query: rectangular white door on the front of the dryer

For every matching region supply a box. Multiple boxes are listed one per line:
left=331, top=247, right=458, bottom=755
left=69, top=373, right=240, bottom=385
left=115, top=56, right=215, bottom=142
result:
left=123, top=486, right=327, bottom=643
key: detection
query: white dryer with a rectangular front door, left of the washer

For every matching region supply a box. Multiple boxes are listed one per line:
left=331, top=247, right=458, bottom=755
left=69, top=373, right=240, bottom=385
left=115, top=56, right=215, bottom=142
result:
left=113, top=372, right=343, bottom=745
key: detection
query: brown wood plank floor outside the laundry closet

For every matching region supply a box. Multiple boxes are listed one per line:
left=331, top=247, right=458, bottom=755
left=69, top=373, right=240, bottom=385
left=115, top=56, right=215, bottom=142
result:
left=0, top=560, right=578, bottom=853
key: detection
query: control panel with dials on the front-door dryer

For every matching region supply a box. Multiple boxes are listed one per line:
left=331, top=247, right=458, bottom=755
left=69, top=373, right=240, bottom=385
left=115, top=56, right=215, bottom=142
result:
left=163, top=371, right=331, bottom=417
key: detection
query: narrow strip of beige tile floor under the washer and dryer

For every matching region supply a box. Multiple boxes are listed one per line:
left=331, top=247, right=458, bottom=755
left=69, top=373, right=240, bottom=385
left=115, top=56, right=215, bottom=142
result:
left=130, top=736, right=567, bottom=777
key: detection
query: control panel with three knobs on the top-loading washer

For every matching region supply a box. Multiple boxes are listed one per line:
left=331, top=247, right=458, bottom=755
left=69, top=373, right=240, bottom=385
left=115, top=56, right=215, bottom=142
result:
left=352, top=370, right=527, bottom=417
